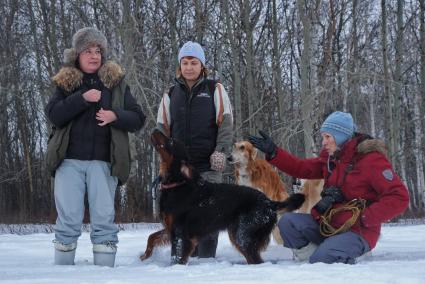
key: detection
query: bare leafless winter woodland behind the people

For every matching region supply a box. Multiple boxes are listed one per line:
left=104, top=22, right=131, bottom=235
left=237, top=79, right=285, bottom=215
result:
left=0, top=0, right=425, bottom=223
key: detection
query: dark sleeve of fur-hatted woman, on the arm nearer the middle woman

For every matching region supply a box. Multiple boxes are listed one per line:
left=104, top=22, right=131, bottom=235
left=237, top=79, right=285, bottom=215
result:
left=111, top=86, right=146, bottom=132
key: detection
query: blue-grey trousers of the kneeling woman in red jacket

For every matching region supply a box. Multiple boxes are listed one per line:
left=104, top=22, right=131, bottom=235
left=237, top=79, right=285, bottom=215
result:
left=278, top=213, right=370, bottom=264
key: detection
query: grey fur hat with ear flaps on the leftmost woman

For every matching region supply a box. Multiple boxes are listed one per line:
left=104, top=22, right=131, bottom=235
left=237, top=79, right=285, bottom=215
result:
left=63, top=27, right=108, bottom=65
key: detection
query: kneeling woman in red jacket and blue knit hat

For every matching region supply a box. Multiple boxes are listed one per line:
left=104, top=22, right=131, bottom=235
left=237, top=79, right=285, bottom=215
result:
left=249, top=111, right=409, bottom=264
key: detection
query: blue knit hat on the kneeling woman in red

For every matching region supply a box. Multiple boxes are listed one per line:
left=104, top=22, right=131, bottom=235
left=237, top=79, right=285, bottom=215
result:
left=320, top=111, right=356, bottom=146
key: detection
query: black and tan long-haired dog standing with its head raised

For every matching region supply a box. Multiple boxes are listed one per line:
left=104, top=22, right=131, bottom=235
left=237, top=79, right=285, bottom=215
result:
left=140, top=131, right=304, bottom=264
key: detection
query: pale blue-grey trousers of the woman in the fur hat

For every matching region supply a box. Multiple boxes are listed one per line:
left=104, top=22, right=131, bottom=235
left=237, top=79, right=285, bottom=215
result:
left=54, top=159, right=118, bottom=244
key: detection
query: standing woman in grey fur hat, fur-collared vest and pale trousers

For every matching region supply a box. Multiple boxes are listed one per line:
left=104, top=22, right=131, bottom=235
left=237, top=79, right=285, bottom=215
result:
left=45, top=27, right=145, bottom=267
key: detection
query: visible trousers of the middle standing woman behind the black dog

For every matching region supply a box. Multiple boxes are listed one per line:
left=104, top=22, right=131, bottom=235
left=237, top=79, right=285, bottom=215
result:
left=192, top=171, right=223, bottom=258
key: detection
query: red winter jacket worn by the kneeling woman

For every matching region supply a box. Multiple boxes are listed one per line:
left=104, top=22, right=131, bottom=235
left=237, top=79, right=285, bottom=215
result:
left=269, top=134, right=409, bottom=249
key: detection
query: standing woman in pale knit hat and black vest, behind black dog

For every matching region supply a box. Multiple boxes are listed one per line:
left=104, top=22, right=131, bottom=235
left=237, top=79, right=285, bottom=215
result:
left=157, top=41, right=233, bottom=257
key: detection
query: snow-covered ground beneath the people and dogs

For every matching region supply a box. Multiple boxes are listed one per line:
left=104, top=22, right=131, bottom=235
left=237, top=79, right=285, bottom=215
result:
left=0, top=224, right=425, bottom=284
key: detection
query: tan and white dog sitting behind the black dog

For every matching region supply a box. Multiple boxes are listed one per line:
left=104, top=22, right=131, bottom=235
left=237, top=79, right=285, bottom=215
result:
left=229, top=141, right=289, bottom=244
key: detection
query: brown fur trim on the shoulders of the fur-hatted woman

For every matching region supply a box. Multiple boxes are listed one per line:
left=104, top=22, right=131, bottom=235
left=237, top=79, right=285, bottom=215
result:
left=52, top=61, right=124, bottom=92
